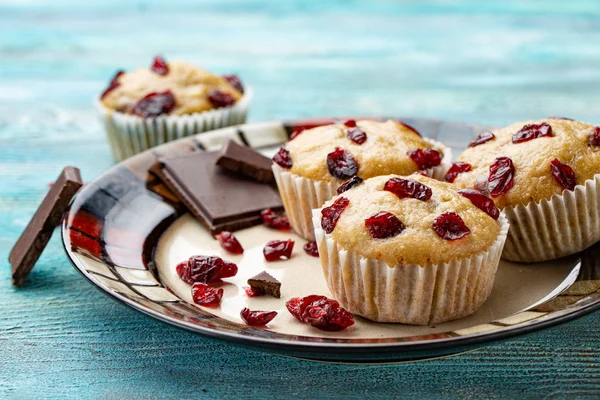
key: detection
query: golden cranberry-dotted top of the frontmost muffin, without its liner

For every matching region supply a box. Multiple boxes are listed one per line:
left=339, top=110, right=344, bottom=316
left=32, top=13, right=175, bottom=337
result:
left=321, top=174, right=500, bottom=266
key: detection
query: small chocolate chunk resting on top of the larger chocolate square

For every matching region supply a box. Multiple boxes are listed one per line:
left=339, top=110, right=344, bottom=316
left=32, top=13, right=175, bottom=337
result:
left=217, top=140, right=275, bottom=183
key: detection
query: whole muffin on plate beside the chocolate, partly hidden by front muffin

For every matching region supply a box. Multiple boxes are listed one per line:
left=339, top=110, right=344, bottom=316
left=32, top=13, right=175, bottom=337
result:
left=273, top=120, right=452, bottom=240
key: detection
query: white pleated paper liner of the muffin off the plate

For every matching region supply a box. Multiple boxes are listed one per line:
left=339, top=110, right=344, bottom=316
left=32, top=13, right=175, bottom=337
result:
left=95, top=87, right=253, bottom=161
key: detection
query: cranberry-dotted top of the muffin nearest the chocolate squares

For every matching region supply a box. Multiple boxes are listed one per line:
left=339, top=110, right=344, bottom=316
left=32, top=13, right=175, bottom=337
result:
left=273, top=120, right=443, bottom=183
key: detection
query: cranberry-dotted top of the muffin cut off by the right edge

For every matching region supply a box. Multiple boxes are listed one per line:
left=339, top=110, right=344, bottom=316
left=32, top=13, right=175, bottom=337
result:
left=446, top=118, right=600, bottom=208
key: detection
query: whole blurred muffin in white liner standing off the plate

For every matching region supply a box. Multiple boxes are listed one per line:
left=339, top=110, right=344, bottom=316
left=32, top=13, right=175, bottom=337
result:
left=96, top=56, right=252, bottom=161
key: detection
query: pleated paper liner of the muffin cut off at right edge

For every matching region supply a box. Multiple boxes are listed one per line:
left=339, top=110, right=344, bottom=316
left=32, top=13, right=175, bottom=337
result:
left=502, top=174, right=600, bottom=262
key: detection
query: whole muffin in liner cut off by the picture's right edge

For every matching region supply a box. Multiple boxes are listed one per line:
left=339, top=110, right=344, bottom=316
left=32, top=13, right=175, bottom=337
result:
left=446, top=118, right=600, bottom=262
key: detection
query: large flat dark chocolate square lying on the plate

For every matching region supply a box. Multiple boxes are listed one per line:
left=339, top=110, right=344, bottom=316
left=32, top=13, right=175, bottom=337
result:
left=151, top=152, right=283, bottom=234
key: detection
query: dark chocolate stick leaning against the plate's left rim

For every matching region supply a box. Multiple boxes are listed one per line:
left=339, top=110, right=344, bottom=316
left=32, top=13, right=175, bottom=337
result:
left=8, top=167, right=83, bottom=286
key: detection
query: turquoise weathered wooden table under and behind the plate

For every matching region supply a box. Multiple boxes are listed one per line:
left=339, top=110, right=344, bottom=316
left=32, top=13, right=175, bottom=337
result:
left=0, top=0, right=600, bottom=399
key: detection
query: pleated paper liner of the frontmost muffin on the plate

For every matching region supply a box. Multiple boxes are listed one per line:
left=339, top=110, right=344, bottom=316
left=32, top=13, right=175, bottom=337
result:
left=313, top=209, right=509, bottom=325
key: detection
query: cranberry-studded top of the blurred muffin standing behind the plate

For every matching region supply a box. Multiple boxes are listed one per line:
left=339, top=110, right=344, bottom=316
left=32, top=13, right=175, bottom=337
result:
left=100, top=57, right=243, bottom=117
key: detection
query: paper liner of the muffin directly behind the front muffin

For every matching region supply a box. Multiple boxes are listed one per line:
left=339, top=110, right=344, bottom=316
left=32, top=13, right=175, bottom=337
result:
left=272, top=139, right=452, bottom=241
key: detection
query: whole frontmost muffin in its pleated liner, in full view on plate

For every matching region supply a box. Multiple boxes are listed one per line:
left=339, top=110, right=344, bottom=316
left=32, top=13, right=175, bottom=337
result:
left=313, top=174, right=508, bottom=325
